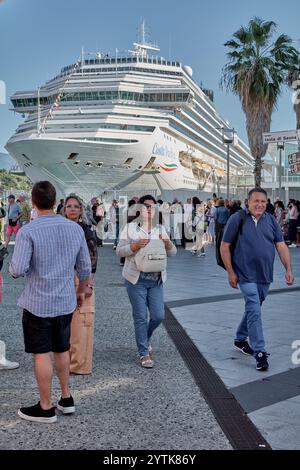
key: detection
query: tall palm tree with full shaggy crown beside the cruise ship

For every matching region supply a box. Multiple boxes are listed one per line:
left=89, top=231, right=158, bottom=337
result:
left=221, top=17, right=299, bottom=187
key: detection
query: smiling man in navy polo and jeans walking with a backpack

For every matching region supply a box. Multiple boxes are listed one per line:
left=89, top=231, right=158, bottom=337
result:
left=220, top=188, right=294, bottom=371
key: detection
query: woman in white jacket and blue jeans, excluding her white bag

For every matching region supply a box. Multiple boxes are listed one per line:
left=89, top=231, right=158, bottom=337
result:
left=117, top=195, right=177, bottom=368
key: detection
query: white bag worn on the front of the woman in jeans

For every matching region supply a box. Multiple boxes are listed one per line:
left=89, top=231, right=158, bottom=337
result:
left=134, top=240, right=167, bottom=273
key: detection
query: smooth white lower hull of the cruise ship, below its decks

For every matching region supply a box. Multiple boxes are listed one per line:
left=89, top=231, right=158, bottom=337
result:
left=6, top=130, right=223, bottom=200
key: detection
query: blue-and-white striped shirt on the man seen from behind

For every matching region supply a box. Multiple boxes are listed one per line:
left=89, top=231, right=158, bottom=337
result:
left=9, top=215, right=91, bottom=317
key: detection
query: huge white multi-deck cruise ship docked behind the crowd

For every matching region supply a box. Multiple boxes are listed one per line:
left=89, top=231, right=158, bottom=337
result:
left=6, top=22, right=253, bottom=201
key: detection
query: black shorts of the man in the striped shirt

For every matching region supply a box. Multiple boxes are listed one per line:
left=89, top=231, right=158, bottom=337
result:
left=22, top=309, right=72, bottom=354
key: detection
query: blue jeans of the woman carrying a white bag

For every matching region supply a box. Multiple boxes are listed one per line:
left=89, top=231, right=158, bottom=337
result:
left=125, top=279, right=165, bottom=356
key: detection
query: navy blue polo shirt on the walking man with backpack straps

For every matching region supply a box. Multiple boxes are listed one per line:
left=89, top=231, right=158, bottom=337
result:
left=223, top=211, right=283, bottom=284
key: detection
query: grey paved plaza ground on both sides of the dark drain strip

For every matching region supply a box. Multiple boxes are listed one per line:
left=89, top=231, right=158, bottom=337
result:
left=0, top=245, right=300, bottom=450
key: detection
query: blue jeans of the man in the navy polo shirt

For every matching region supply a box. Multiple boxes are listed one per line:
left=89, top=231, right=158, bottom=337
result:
left=235, top=282, right=270, bottom=353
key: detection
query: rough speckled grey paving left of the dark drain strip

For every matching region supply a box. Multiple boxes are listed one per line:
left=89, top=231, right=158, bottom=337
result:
left=0, top=246, right=231, bottom=450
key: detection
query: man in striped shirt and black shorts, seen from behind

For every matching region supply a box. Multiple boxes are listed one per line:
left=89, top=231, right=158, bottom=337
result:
left=10, top=181, right=91, bottom=423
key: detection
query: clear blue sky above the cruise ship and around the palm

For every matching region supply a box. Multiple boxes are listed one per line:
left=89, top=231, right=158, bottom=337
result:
left=0, top=0, right=300, bottom=152
